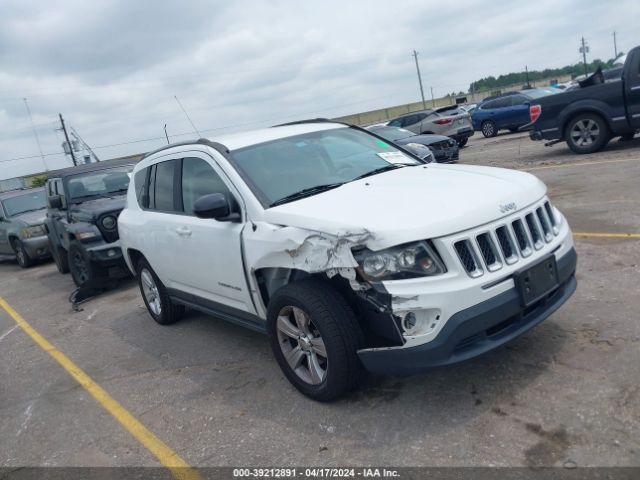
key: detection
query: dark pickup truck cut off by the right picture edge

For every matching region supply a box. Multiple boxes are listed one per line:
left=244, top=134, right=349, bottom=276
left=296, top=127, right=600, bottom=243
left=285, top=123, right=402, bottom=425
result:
left=523, top=47, right=640, bottom=154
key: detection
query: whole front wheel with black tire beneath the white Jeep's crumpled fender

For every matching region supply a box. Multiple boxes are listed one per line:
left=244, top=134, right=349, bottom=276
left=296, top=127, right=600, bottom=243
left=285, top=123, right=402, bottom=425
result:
left=267, top=279, right=362, bottom=402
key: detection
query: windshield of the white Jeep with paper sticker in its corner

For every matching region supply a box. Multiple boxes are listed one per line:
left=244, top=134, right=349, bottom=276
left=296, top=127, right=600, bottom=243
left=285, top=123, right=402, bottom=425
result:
left=231, top=128, right=421, bottom=206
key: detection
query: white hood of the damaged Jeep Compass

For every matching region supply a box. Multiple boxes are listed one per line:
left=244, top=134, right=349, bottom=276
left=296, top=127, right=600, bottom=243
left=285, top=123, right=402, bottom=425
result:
left=264, top=164, right=546, bottom=250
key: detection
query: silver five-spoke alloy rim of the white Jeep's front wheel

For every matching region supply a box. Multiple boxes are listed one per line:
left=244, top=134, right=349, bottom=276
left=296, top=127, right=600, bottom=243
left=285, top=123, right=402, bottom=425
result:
left=276, top=306, right=329, bottom=385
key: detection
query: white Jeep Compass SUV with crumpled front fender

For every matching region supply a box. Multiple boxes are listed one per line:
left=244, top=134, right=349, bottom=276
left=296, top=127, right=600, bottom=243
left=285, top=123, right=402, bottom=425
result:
left=118, top=120, right=576, bottom=401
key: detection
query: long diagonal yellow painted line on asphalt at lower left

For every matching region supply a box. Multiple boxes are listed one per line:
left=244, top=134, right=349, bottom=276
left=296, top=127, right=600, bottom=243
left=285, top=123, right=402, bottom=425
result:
left=0, top=297, right=200, bottom=480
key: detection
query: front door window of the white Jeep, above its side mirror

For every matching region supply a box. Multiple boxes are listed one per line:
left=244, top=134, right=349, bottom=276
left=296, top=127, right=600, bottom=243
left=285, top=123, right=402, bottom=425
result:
left=182, top=158, right=232, bottom=215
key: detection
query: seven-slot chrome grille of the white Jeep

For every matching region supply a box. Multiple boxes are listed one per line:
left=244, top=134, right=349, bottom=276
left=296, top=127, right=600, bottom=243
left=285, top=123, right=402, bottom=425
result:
left=454, top=201, right=560, bottom=277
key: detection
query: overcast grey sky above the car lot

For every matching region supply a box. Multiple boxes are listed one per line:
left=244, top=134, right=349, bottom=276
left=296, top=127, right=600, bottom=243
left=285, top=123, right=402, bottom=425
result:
left=0, top=0, right=640, bottom=179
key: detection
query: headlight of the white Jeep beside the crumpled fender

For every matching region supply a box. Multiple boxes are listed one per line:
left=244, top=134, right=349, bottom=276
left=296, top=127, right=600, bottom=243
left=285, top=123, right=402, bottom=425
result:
left=353, top=241, right=447, bottom=280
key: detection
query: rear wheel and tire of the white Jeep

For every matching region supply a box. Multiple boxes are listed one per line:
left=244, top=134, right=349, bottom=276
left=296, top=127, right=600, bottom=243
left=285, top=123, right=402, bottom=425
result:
left=136, top=258, right=185, bottom=325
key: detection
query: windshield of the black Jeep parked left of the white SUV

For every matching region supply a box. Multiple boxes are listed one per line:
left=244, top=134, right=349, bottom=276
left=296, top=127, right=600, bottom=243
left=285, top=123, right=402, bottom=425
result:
left=67, top=165, right=133, bottom=203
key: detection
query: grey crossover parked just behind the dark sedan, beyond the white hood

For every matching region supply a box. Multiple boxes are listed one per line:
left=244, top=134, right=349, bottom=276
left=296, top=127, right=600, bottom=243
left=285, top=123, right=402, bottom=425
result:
left=387, top=105, right=473, bottom=147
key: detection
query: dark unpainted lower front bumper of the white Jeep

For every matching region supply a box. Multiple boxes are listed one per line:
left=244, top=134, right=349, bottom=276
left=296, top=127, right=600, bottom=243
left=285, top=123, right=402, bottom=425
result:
left=358, top=248, right=577, bottom=374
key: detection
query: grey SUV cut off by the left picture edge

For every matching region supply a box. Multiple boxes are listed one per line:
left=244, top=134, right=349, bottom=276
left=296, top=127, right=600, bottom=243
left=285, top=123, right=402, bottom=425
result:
left=0, top=188, right=50, bottom=268
